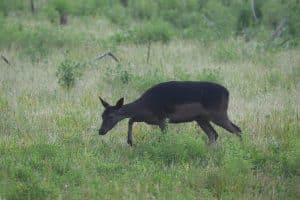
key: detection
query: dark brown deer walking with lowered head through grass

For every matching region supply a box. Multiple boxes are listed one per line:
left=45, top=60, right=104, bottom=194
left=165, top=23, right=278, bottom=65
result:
left=99, top=81, right=241, bottom=146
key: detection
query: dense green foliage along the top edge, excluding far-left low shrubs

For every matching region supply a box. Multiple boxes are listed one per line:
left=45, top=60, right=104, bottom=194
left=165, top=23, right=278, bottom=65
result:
left=0, top=0, right=300, bottom=47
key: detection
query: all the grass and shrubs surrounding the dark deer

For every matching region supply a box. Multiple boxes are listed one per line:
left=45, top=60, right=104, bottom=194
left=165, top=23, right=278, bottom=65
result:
left=0, top=0, right=300, bottom=200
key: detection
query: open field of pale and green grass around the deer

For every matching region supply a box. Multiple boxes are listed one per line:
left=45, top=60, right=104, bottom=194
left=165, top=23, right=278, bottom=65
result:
left=0, top=13, right=300, bottom=199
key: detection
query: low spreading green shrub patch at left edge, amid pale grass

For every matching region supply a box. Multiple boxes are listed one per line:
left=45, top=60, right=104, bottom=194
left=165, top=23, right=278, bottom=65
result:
left=0, top=18, right=80, bottom=61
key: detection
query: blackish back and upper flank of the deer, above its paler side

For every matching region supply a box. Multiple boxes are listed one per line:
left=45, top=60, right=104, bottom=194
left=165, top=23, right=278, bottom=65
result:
left=139, top=81, right=229, bottom=112
